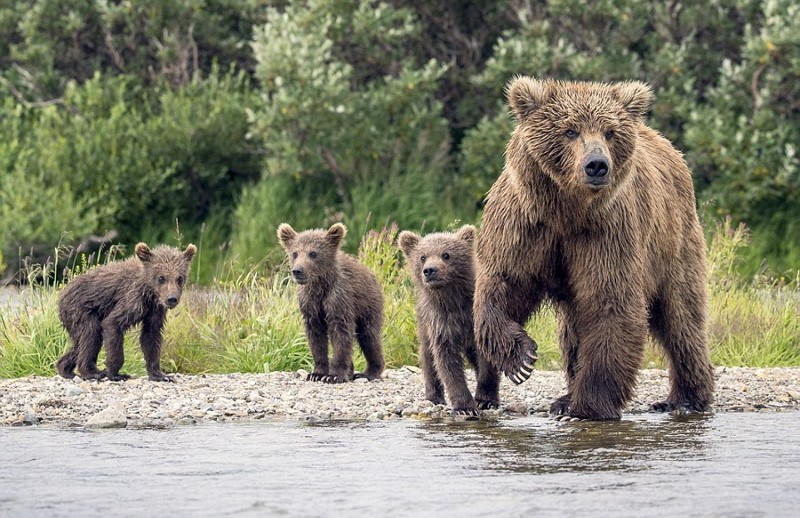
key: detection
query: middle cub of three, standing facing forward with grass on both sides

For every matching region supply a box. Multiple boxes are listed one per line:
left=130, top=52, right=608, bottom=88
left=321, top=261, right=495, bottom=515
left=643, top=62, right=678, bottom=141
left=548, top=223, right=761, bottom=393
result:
left=278, top=223, right=384, bottom=383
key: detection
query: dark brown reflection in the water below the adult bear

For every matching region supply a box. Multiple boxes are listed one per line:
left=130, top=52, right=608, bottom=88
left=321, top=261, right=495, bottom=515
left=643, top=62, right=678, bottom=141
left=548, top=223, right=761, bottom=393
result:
left=418, top=415, right=713, bottom=473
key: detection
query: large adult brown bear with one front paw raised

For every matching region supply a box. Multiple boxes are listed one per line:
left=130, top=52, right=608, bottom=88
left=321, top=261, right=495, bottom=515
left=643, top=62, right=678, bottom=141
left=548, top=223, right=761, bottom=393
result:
left=475, top=77, right=714, bottom=419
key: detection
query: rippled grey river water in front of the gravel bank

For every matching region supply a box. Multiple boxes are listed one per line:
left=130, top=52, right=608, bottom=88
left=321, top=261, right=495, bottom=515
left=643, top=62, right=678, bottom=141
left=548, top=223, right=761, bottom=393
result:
left=0, top=412, right=800, bottom=517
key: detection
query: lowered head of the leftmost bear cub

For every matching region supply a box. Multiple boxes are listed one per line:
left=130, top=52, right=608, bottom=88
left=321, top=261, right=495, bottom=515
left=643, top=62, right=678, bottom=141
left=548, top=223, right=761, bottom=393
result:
left=134, top=243, right=197, bottom=309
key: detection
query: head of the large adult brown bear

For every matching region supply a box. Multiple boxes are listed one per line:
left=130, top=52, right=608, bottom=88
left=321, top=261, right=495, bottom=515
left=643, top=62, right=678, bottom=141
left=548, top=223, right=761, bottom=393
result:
left=507, top=76, right=653, bottom=196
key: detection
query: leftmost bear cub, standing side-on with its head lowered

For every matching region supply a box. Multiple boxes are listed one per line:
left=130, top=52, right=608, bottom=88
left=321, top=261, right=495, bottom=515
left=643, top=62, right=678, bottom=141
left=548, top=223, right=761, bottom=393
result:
left=56, top=243, right=197, bottom=381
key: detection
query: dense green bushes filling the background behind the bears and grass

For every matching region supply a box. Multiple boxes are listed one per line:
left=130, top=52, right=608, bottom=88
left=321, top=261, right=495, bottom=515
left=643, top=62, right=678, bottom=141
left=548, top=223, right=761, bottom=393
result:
left=0, top=0, right=800, bottom=283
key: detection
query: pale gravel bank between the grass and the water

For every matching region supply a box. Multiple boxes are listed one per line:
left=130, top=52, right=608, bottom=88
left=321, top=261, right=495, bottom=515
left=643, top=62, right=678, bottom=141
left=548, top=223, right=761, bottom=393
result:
left=0, top=367, right=800, bottom=428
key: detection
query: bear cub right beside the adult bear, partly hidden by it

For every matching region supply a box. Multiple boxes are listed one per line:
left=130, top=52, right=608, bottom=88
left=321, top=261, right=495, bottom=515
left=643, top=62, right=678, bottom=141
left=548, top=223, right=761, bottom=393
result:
left=397, top=225, right=500, bottom=416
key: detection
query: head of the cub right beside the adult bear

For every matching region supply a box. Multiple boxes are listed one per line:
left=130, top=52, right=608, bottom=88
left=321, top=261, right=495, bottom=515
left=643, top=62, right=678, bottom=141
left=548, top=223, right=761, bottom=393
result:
left=397, top=225, right=475, bottom=290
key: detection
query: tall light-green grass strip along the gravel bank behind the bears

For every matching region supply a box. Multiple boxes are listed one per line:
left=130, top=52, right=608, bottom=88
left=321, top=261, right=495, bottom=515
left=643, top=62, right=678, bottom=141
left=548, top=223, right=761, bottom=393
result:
left=0, top=220, right=800, bottom=378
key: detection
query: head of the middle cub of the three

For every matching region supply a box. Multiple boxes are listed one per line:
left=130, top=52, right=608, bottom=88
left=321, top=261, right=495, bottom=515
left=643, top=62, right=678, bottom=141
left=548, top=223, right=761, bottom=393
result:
left=278, top=223, right=347, bottom=285
